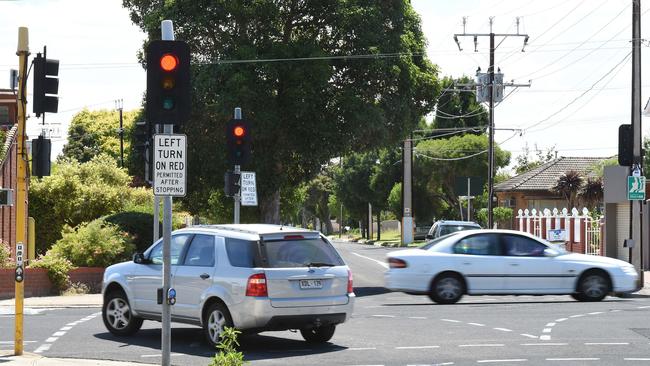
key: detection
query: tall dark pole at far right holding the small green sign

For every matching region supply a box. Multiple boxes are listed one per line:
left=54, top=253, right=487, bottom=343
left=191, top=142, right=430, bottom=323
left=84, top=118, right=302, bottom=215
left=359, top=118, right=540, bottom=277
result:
left=630, top=0, right=645, bottom=285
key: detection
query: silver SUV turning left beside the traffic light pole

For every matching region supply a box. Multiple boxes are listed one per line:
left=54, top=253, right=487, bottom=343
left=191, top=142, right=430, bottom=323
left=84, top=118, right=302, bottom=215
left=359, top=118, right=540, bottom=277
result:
left=102, top=224, right=355, bottom=345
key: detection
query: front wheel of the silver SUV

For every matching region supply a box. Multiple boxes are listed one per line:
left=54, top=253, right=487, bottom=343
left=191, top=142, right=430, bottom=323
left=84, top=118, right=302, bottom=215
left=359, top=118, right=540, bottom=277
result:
left=102, top=291, right=143, bottom=336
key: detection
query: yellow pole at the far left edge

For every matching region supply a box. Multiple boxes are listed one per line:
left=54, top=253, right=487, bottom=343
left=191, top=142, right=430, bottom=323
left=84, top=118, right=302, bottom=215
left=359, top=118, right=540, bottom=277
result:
left=14, top=27, right=29, bottom=356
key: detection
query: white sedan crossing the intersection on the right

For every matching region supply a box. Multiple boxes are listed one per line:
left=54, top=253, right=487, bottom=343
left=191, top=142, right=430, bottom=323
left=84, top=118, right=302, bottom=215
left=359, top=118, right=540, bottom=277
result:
left=385, top=230, right=638, bottom=304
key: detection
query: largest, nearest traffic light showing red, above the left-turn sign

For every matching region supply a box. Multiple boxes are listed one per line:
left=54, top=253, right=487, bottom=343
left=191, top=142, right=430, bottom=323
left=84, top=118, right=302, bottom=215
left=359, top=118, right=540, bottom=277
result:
left=146, top=41, right=192, bottom=125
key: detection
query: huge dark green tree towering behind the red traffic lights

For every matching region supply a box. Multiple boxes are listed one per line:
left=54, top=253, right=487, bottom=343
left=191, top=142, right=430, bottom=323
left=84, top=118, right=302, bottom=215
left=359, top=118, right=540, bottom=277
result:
left=123, top=0, right=439, bottom=223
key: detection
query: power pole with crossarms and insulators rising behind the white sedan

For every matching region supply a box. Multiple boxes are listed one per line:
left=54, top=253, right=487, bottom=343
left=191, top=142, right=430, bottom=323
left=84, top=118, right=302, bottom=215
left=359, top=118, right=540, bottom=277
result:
left=454, top=17, right=530, bottom=229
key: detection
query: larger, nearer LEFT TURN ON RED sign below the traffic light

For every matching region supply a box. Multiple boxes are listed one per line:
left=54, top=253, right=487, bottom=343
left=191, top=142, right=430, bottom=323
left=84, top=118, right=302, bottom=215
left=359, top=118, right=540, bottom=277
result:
left=153, top=134, right=187, bottom=197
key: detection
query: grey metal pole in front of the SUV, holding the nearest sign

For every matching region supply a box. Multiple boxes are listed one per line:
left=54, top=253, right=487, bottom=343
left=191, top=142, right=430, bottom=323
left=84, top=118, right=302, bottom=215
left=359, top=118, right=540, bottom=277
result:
left=156, top=20, right=174, bottom=366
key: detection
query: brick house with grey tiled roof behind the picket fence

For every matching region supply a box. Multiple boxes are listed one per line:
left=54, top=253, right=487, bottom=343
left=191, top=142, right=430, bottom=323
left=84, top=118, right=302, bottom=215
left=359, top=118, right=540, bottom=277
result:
left=494, top=156, right=608, bottom=213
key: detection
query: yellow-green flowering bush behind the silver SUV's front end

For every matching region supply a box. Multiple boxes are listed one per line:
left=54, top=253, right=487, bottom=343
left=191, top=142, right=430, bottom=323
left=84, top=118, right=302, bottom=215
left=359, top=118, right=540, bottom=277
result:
left=47, top=219, right=135, bottom=267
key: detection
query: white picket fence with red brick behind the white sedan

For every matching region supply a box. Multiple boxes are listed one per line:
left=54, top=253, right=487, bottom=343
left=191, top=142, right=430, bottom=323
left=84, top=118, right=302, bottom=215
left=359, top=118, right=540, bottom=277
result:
left=515, top=207, right=603, bottom=255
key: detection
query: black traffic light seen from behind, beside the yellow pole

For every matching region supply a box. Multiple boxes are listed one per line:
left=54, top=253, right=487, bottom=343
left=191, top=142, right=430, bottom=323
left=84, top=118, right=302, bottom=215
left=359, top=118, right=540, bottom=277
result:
left=33, top=53, right=59, bottom=117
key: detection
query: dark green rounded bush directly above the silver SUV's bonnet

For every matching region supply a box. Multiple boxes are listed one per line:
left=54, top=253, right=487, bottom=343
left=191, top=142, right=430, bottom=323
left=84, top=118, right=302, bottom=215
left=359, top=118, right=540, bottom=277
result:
left=104, top=211, right=162, bottom=252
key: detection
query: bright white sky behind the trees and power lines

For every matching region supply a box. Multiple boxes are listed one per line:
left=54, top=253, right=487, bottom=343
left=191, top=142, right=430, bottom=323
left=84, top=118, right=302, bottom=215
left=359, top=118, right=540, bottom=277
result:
left=0, top=0, right=650, bottom=167
